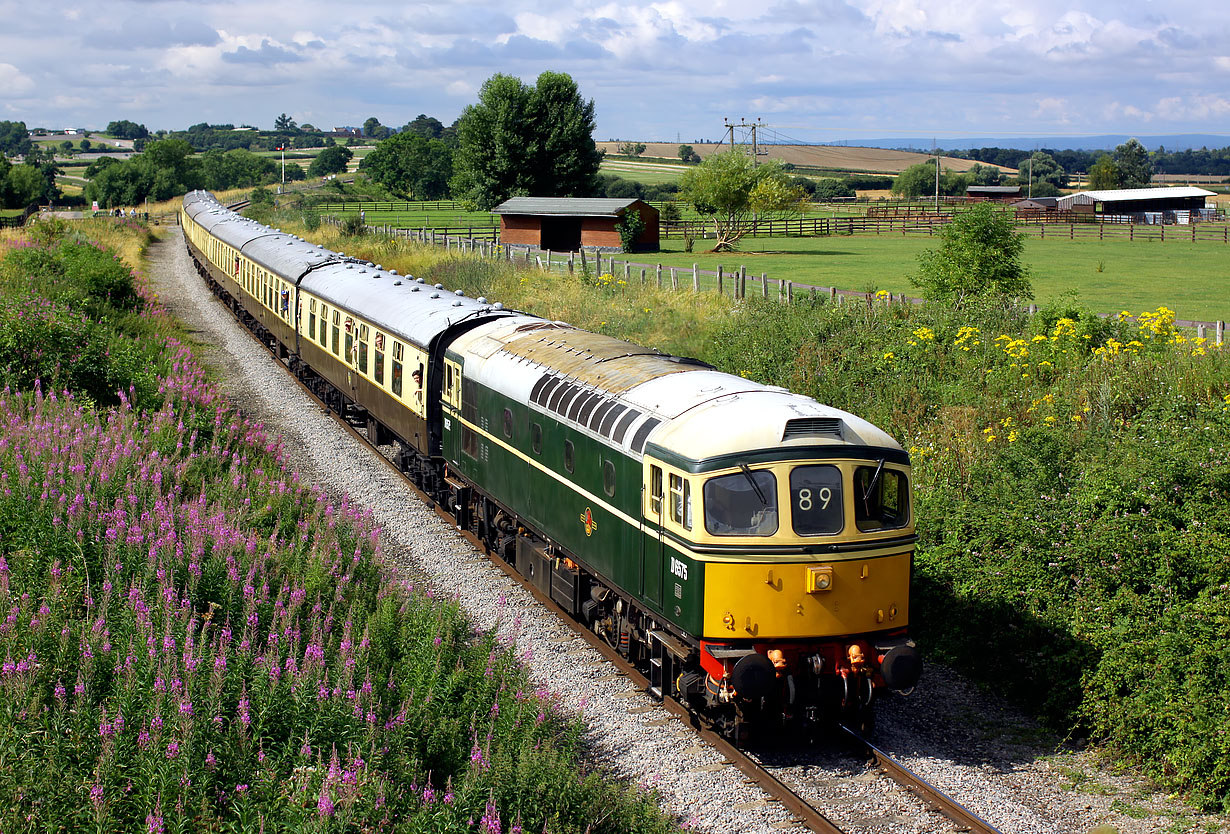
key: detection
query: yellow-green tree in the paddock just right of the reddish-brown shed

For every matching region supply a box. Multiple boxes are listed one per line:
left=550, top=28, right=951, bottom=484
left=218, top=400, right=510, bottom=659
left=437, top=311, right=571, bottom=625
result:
left=679, top=150, right=806, bottom=252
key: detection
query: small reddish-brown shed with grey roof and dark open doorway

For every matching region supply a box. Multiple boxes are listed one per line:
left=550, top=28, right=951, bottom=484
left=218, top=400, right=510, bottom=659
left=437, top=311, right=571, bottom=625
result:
left=492, top=197, right=658, bottom=252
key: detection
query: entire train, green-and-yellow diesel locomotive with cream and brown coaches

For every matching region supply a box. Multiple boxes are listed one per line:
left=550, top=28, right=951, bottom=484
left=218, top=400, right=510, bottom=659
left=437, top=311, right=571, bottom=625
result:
left=183, top=192, right=921, bottom=734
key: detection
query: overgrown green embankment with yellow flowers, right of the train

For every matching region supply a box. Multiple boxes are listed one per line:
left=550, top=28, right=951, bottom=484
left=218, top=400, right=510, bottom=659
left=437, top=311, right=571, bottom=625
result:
left=269, top=214, right=1230, bottom=809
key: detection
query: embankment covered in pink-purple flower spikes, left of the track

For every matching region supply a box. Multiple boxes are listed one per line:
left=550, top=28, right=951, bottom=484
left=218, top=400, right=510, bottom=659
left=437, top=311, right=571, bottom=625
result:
left=0, top=219, right=674, bottom=834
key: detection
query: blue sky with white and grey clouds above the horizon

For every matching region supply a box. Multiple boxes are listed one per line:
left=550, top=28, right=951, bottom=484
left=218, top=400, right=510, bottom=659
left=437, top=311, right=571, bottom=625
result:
left=0, top=0, right=1230, bottom=145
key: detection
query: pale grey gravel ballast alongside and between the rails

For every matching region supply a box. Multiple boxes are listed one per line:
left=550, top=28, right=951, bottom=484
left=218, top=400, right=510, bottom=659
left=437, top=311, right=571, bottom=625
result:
left=149, top=228, right=1230, bottom=834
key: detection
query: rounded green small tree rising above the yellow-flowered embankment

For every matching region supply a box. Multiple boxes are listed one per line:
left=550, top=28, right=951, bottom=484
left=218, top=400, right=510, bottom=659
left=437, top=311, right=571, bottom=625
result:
left=911, top=203, right=1033, bottom=306
